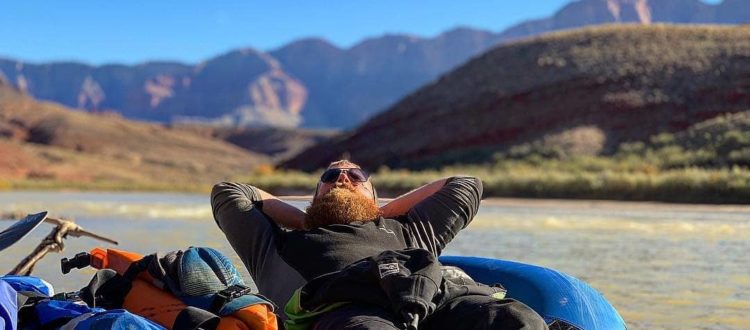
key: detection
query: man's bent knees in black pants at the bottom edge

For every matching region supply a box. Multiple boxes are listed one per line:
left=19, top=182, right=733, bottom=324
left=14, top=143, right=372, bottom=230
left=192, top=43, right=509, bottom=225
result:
left=314, top=296, right=547, bottom=330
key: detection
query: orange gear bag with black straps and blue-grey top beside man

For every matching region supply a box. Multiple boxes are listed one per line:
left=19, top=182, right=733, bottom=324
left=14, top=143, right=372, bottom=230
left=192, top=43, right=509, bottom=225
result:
left=63, top=247, right=278, bottom=329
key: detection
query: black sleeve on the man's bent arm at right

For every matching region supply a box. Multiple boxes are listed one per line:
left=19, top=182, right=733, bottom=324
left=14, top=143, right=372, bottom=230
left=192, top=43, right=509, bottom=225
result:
left=404, top=176, right=482, bottom=256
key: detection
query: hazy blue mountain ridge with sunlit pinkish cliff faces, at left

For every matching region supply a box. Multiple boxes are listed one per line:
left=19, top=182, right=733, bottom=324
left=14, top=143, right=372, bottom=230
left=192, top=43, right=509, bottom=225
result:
left=0, top=49, right=307, bottom=127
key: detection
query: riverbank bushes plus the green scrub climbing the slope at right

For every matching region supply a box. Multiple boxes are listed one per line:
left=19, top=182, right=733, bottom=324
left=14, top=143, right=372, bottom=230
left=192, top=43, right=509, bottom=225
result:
left=5, top=111, right=750, bottom=204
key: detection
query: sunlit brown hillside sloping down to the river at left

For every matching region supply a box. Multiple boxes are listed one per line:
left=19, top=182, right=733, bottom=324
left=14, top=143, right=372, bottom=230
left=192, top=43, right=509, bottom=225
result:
left=0, top=82, right=270, bottom=189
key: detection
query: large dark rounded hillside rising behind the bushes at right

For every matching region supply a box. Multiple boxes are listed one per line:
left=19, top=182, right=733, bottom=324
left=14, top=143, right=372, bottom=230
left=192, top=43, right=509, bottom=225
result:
left=284, top=25, right=750, bottom=170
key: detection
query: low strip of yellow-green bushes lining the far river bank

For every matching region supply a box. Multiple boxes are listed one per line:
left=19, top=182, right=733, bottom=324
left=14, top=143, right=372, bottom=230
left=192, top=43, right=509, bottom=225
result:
left=0, top=157, right=750, bottom=204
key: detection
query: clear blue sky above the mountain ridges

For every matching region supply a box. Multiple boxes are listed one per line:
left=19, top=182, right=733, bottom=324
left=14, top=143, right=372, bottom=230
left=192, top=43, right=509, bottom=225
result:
left=0, top=0, right=721, bottom=64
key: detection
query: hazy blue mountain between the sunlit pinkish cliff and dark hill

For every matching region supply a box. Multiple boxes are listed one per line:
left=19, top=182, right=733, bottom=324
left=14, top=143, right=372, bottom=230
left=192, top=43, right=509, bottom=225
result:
left=271, top=28, right=500, bottom=127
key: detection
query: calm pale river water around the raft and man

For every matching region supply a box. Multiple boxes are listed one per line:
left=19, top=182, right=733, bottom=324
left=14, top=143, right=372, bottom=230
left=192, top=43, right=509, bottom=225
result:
left=0, top=192, right=750, bottom=329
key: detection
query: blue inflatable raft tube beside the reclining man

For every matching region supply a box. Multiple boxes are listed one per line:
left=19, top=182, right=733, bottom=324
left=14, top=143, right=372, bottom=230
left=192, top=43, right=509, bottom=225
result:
left=440, top=256, right=626, bottom=330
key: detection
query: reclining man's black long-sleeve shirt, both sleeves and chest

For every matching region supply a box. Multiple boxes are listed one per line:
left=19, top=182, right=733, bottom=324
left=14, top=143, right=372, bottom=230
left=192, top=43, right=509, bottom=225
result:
left=211, top=176, right=482, bottom=305
